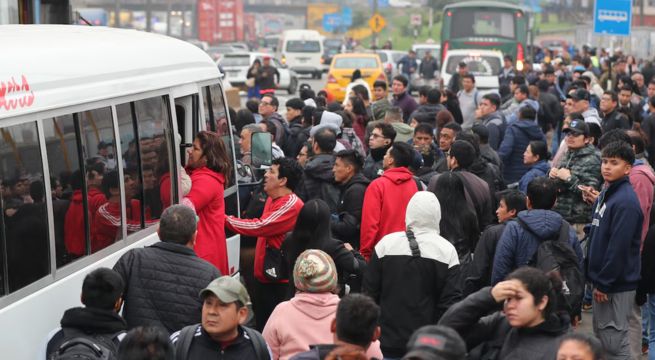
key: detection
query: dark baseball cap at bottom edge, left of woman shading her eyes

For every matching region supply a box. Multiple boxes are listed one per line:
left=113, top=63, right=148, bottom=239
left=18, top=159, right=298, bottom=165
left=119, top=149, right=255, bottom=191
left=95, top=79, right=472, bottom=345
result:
left=403, top=325, right=466, bottom=360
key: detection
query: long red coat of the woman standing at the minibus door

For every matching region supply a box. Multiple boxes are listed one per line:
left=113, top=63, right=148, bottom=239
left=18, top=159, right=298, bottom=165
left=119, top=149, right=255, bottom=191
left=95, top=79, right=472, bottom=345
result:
left=184, top=167, right=230, bottom=275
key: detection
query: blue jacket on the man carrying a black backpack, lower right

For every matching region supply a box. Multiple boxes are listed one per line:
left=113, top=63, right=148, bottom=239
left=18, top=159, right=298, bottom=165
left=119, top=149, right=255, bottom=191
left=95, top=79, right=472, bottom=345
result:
left=491, top=210, right=583, bottom=286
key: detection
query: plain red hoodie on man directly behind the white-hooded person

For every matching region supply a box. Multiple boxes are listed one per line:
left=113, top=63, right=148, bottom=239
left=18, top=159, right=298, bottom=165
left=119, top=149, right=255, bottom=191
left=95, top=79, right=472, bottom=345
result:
left=360, top=167, right=418, bottom=261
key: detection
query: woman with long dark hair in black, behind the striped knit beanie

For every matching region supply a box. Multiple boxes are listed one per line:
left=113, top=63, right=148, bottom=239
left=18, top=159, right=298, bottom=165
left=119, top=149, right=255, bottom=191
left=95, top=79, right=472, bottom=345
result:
left=282, top=199, right=366, bottom=298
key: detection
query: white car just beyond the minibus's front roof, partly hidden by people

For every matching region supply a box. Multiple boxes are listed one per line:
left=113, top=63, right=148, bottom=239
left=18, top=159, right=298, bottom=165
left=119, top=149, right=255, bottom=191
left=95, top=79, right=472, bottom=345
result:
left=218, top=52, right=298, bottom=95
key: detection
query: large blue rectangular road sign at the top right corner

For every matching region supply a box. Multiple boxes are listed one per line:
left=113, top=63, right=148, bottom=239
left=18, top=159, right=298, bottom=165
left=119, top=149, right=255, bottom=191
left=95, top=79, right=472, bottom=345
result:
left=594, top=0, right=632, bottom=36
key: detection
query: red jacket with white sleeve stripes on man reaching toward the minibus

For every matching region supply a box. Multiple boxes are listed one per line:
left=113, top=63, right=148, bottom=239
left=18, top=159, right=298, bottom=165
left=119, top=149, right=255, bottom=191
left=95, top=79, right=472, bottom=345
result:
left=225, top=193, right=303, bottom=283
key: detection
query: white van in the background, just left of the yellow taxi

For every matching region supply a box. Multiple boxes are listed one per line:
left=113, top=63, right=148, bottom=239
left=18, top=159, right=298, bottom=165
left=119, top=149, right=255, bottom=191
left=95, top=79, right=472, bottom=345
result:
left=278, top=30, right=323, bottom=79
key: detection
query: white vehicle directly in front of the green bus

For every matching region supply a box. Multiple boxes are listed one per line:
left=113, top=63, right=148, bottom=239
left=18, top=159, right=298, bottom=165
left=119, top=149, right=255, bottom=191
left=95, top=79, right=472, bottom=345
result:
left=441, top=50, right=503, bottom=93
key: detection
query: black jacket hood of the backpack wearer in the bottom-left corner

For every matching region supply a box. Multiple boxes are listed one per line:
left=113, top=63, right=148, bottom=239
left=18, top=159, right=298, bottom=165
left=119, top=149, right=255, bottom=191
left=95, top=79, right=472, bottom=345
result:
left=61, top=307, right=127, bottom=334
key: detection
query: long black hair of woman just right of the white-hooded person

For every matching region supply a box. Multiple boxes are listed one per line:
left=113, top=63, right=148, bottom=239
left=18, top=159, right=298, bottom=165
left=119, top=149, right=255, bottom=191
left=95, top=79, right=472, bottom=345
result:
left=435, top=172, right=480, bottom=266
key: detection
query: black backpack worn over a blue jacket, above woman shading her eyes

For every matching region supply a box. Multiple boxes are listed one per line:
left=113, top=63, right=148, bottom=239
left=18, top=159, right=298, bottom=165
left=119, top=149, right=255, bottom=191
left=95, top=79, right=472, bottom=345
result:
left=516, top=218, right=585, bottom=319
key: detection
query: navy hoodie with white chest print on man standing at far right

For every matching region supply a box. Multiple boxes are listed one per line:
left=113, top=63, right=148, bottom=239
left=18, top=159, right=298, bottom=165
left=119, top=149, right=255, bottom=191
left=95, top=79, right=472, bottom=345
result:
left=587, top=177, right=644, bottom=294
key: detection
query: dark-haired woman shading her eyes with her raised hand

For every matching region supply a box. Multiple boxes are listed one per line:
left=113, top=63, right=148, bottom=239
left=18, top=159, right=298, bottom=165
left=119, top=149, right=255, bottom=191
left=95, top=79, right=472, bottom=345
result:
left=439, top=266, right=571, bottom=360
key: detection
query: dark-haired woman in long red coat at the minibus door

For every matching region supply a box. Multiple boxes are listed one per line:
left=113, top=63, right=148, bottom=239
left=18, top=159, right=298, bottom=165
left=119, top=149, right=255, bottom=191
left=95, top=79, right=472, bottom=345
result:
left=182, top=131, right=232, bottom=275
